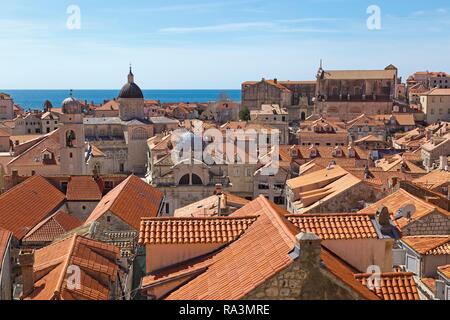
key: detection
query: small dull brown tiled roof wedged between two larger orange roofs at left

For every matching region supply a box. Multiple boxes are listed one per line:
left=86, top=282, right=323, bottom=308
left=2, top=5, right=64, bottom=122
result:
left=22, top=211, right=83, bottom=244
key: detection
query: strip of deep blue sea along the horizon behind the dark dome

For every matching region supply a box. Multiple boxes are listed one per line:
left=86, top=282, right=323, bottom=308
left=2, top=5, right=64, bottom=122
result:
left=0, top=89, right=241, bottom=110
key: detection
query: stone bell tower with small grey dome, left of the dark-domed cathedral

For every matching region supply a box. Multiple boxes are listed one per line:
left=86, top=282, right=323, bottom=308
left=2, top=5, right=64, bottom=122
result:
left=59, top=90, right=86, bottom=175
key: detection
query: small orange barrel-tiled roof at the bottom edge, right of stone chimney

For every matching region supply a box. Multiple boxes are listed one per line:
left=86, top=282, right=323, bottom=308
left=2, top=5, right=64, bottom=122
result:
left=355, top=272, right=420, bottom=300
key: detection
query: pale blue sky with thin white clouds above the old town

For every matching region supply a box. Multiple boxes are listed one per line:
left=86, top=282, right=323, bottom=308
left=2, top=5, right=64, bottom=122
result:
left=0, top=0, right=450, bottom=89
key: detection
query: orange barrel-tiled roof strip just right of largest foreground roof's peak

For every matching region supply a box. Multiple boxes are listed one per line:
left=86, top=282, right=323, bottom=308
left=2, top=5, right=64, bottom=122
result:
left=286, top=213, right=378, bottom=240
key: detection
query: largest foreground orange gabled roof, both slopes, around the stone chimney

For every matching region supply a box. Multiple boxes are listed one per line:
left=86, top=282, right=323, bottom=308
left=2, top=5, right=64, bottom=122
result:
left=143, top=196, right=377, bottom=300
